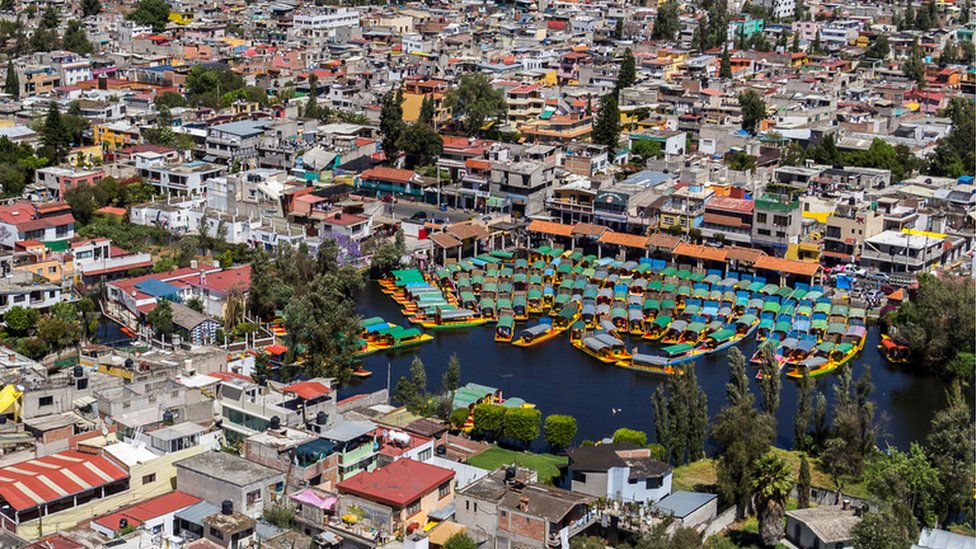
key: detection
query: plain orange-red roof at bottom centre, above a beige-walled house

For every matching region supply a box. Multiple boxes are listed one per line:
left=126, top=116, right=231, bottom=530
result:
left=339, top=459, right=454, bottom=508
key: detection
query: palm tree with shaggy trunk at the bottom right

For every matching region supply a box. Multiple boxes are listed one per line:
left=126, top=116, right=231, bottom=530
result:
left=752, top=452, right=793, bottom=546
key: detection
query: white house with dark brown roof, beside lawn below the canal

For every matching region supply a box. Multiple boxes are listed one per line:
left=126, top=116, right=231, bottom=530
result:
left=565, top=444, right=671, bottom=503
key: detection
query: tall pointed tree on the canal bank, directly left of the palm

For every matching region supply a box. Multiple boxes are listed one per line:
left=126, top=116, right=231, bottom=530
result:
left=711, top=347, right=775, bottom=519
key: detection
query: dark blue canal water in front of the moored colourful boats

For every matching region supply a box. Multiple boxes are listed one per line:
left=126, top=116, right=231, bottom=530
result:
left=340, top=282, right=945, bottom=449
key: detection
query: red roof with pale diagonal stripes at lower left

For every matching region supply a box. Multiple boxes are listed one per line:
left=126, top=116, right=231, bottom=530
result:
left=0, top=450, right=129, bottom=511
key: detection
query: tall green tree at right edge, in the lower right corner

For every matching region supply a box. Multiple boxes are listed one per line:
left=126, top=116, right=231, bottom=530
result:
left=925, top=382, right=976, bottom=519
